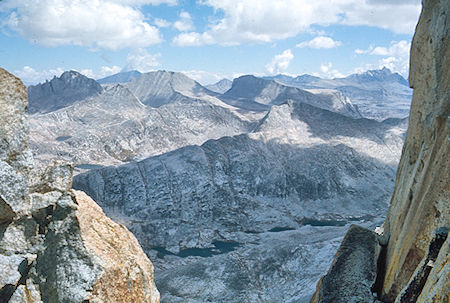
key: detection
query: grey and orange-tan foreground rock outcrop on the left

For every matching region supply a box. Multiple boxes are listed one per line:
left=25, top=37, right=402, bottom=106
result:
left=0, top=69, right=159, bottom=303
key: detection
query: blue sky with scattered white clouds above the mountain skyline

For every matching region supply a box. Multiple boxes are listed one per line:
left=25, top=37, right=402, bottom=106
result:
left=0, top=0, right=421, bottom=85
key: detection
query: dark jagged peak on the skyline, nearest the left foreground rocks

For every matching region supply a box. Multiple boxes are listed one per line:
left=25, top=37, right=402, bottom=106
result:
left=28, top=71, right=103, bottom=113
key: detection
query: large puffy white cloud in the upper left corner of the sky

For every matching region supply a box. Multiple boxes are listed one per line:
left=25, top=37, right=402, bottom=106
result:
left=3, top=0, right=163, bottom=50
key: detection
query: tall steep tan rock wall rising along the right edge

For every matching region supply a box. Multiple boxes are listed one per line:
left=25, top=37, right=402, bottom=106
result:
left=383, top=0, right=450, bottom=302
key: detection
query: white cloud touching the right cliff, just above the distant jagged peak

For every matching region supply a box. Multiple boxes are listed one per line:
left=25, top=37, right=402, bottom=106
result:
left=355, top=40, right=411, bottom=77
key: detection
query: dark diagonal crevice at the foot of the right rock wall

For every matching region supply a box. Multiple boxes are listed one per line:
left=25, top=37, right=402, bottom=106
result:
left=400, top=227, right=449, bottom=303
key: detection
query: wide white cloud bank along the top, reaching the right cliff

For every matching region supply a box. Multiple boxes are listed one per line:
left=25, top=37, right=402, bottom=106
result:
left=173, top=0, right=421, bottom=46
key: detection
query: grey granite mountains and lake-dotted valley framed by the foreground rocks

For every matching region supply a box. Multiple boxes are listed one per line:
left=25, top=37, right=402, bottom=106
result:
left=25, top=67, right=407, bottom=302
